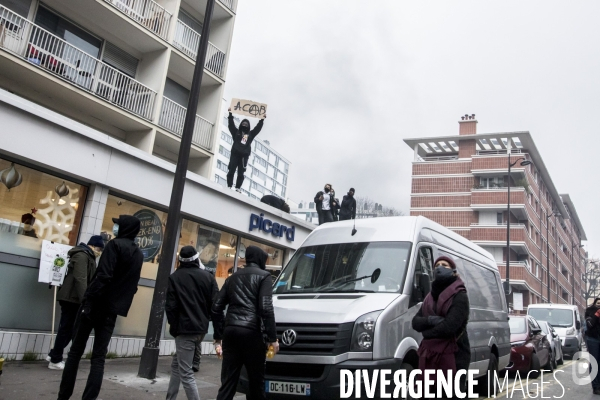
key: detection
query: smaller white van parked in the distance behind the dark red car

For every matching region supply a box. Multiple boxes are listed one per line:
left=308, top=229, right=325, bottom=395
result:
left=527, top=304, right=583, bottom=357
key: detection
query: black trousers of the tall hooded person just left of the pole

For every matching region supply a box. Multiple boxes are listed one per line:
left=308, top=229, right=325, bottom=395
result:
left=58, top=310, right=117, bottom=400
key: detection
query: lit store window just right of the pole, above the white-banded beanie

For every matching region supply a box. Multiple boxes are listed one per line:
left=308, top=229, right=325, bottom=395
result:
left=177, top=219, right=238, bottom=288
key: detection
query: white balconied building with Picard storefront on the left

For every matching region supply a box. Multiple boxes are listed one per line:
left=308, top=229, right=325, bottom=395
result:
left=0, top=0, right=313, bottom=359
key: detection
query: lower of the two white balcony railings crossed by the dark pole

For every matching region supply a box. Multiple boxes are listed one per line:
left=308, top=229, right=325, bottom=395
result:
left=158, top=97, right=214, bottom=151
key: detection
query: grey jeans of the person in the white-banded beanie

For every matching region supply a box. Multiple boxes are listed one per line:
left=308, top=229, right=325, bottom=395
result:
left=167, top=335, right=204, bottom=400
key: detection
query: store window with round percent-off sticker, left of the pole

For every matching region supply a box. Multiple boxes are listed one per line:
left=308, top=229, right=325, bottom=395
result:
left=100, top=194, right=167, bottom=280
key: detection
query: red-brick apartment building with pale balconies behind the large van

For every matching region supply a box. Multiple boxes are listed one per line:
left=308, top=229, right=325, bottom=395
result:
left=404, top=115, right=586, bottom=312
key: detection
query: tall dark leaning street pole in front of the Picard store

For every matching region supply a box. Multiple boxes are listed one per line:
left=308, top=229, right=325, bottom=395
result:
left=138, top=0, right=215, bottom=379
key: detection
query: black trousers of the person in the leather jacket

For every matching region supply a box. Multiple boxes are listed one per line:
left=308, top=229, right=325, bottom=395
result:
left=217, top=326, right=267, bottom=400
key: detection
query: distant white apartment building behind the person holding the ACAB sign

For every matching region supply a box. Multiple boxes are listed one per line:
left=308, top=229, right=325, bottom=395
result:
left=214, top=99, right=291, bottom=200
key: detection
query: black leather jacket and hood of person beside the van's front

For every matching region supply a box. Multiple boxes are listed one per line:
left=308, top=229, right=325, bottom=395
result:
left=212, top=246, right=277, bottom=342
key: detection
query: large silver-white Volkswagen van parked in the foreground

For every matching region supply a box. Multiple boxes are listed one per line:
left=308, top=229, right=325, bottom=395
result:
left=238, top=217, right=510, bottom=399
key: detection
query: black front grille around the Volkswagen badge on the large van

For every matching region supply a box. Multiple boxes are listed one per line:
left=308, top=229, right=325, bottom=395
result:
left=277, top=322, right=354, bottom=356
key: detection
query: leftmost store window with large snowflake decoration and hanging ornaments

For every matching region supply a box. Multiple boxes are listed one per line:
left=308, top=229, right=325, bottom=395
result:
left=0, top=158, right=87, bottom=248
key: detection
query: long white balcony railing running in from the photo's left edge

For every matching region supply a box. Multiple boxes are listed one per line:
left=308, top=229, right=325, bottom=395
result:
left=0, top=6, right=156, bottom=120
